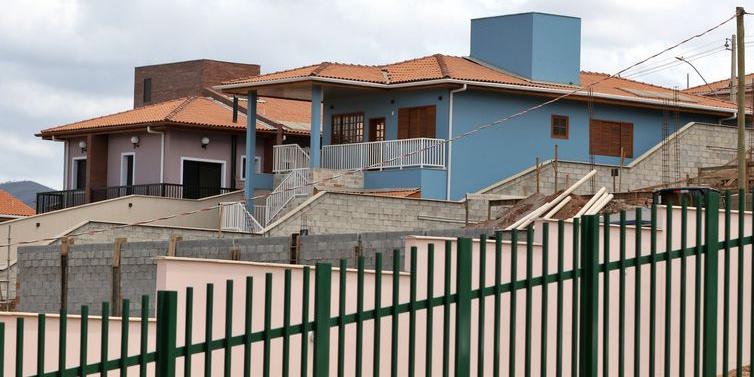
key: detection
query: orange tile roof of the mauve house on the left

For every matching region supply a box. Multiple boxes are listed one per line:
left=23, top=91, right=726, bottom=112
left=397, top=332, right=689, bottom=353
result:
left=39, top=97, right=309, bottom=137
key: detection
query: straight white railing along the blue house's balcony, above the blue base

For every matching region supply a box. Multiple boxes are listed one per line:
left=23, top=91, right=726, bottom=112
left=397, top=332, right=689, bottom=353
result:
left=322, top=138, right=445, bottom=170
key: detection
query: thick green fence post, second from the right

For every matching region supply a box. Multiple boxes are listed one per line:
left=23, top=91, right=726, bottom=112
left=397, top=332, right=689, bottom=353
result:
left=579, top=215, right=599, bottom=377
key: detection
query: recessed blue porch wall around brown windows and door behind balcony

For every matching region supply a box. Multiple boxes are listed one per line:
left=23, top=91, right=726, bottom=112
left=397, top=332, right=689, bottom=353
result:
left=322, top=89, right=449, bottom=145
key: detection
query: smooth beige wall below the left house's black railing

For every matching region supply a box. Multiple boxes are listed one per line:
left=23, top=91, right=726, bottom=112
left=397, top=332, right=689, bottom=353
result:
left=0, top=192, right=242, bottom=265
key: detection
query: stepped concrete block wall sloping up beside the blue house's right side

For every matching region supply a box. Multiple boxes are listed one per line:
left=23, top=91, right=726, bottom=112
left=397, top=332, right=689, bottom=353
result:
left=480, top=123, right=737, bottom=196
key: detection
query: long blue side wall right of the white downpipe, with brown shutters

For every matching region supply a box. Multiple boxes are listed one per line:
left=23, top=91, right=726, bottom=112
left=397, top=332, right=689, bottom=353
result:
left=451, top=90, right=717, bottom=199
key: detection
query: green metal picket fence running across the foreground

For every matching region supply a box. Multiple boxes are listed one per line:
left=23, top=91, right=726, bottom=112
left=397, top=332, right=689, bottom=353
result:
left=0, top=192, right=754, bottom=377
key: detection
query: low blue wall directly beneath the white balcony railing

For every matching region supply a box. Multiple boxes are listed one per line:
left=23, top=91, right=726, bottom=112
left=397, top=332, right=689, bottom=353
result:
left=364, top=168, right=448, bottom=199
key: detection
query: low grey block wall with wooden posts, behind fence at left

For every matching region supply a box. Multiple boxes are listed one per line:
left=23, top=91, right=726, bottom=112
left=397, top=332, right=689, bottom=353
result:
left=17, top=229, right=493, bottom=316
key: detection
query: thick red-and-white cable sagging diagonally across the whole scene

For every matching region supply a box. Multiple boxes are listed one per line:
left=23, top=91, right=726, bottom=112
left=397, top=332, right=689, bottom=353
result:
left=0, top=14, right=736, bottom=248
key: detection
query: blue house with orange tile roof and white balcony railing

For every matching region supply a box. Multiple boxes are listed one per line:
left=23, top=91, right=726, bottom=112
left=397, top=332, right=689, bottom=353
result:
left=219, top=13, right=735, bottom=206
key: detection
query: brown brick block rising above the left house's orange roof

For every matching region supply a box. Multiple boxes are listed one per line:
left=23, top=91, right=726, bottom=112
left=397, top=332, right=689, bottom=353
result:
left=134, top=59, right=259, bottom=108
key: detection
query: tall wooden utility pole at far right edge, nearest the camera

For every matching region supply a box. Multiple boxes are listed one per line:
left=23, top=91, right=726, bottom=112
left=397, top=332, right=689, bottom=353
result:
left=736, top=7, right=748, bottom=191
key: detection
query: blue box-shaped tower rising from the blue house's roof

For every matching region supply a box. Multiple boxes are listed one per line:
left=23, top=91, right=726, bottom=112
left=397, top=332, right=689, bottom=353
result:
left=470, top=12, right=581, bottom=85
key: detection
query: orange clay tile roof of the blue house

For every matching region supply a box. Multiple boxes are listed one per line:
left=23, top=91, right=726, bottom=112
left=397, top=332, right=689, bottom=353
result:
left=220, top=54, right=734, bottom=111
